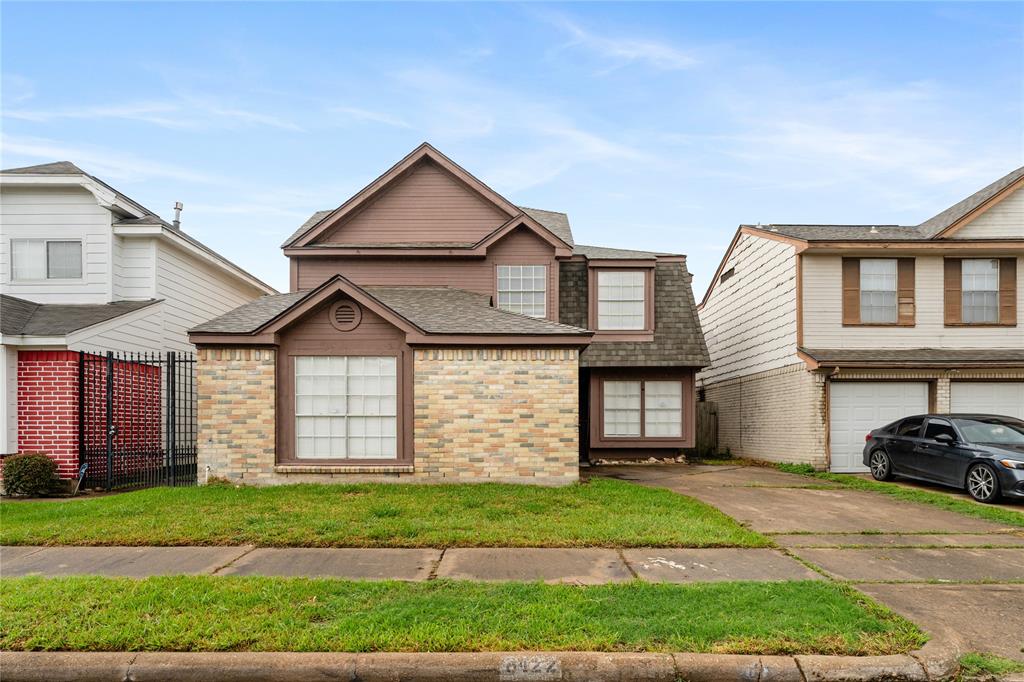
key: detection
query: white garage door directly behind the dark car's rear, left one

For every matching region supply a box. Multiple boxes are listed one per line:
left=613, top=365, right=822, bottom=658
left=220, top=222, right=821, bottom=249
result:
left=828, top=381, right=928, bottom=473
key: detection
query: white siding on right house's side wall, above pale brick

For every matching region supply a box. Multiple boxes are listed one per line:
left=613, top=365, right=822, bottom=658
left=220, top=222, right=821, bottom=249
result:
left=697, top=235, right=797, bottom=384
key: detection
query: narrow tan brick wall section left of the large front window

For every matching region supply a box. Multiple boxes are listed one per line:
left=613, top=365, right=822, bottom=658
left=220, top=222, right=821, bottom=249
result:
left=196, top=348, right=276, bottom=483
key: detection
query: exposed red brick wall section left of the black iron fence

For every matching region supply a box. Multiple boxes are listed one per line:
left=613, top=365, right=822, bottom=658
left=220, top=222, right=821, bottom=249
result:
left=17, top=350, right=78, bottom=478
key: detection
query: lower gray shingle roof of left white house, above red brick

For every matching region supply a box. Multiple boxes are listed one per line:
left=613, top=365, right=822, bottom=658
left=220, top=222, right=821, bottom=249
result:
left=0, top=294, right=158, bottom=336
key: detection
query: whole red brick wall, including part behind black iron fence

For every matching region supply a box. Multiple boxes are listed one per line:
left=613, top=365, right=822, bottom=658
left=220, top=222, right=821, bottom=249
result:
left=17, top=350, right=163, bottom=478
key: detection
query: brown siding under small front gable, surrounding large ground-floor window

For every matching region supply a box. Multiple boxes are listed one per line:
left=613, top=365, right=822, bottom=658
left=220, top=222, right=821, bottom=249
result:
left=276, top=295, right=413, bottom=464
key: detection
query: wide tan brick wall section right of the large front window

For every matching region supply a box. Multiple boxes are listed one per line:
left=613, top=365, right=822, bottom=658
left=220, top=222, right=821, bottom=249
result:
left=414, top=348, right=580, bottom=484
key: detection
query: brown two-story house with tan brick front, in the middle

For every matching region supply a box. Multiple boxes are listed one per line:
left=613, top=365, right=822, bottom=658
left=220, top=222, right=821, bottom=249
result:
left=190, top=144, right=708, bottom=484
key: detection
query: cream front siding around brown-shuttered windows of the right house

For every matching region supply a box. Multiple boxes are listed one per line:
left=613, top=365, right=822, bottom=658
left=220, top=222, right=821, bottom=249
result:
left=804, top=254, right=1024, bottom=348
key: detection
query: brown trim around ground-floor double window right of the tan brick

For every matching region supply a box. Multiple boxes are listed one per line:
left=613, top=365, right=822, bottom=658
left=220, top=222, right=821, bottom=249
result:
left=590, top=368, right=696, bottom=450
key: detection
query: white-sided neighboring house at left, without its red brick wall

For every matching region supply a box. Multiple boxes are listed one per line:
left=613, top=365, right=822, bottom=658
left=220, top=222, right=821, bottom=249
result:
left=0, top=162, right=276, bottom=454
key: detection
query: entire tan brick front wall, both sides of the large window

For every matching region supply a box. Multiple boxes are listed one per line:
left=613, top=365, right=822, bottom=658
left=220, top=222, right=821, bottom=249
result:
left=197, top=348, right=579, bottom=485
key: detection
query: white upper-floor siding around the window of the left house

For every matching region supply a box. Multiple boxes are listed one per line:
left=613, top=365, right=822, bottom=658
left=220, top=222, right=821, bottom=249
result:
left=0, top=185, right=113, bottom=303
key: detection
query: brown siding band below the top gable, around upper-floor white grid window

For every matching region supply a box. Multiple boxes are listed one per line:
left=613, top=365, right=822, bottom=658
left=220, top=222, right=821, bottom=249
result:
left=292, top=228, right=558, bottom=321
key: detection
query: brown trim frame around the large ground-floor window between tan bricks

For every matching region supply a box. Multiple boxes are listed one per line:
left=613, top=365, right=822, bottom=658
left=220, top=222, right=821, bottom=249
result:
left=274, top=344, right=414, bottom=467
